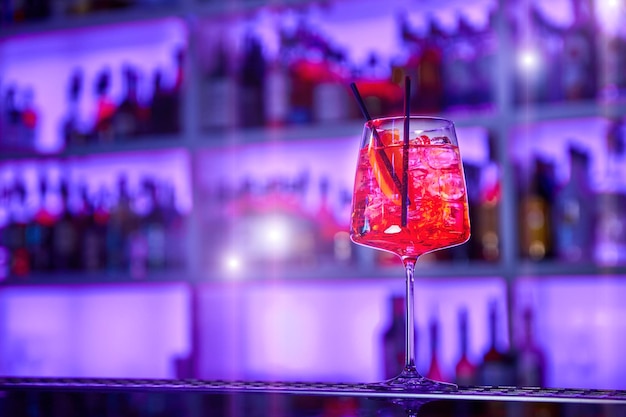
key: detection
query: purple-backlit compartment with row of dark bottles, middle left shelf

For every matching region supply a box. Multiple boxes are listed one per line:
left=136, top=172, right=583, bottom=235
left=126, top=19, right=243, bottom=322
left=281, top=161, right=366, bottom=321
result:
left=0, top=150, right=192, bottom=283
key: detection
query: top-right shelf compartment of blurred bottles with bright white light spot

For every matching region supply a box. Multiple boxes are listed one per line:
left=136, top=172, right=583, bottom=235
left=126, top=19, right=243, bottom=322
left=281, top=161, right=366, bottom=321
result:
left=507, top=0, right=626, bottom=107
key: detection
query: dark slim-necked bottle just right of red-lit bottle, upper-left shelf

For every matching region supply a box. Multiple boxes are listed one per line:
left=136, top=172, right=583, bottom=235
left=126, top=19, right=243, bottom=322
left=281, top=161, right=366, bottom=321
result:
left=112, top=66, right=142, bottom=140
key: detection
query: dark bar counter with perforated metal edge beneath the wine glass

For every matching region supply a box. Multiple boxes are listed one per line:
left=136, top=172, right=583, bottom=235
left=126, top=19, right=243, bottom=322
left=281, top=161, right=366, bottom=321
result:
left=0, top=378, right=626, bottom=417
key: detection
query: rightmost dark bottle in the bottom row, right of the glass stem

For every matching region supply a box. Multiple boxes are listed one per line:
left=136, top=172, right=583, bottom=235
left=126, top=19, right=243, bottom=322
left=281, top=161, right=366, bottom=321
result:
left=516, top=307, right=546, bottom=387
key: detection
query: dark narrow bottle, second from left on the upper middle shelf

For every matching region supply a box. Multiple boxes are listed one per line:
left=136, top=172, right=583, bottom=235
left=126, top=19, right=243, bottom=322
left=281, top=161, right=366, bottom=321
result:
left=238, top=33, right=266, bottom=127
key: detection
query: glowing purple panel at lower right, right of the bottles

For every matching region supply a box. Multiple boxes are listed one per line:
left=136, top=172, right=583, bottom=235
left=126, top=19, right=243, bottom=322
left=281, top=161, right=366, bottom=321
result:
left=514, top=276, right=626, bottom=389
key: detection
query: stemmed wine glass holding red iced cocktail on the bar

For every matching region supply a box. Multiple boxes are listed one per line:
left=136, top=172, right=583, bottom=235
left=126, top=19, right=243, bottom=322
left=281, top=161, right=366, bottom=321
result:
left=350, top=116, right=470, bottom=391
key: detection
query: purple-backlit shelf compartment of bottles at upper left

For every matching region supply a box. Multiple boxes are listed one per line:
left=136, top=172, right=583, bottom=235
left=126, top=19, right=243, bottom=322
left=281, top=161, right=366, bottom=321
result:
left=0, top=18, right=187, bottom=159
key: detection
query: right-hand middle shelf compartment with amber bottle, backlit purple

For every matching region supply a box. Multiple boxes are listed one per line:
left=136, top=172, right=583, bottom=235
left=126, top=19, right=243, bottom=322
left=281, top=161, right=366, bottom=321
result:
left=510, top=117, right=626, bottom=273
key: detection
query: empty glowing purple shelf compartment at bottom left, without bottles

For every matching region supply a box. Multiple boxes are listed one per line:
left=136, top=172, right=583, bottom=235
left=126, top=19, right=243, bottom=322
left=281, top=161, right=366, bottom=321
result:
left=0, top=283, right=190, bottom=378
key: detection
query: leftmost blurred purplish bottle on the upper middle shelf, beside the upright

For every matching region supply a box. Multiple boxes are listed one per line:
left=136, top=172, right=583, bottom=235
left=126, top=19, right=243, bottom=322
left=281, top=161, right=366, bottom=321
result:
left=200, top=40, right=239, bottom=129
